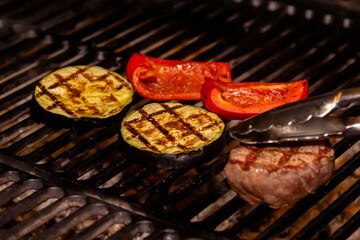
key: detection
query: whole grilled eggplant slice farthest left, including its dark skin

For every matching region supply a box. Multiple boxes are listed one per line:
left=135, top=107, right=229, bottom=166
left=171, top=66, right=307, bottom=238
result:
left=31, top=66, right=134, bottom=128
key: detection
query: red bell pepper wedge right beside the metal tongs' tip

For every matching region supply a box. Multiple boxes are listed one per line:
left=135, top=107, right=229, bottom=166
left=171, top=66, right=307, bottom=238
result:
left=201, top=78, right=308, bottom=120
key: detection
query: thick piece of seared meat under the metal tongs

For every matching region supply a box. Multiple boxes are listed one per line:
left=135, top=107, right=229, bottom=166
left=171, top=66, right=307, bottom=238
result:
left=225, top=142, right=334, bottom=208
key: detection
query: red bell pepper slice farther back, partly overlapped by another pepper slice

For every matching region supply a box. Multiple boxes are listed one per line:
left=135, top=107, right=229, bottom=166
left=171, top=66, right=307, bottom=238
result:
left=126, top=53, right=232, bottom=101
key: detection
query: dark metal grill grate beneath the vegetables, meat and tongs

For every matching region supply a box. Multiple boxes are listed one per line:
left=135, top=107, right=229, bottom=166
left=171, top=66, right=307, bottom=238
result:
left=0, top=0, right=360, bottom=239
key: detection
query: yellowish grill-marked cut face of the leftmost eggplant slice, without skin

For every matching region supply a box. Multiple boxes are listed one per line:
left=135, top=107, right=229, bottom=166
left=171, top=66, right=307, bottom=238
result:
left=33, top=65, right=133, bottom=122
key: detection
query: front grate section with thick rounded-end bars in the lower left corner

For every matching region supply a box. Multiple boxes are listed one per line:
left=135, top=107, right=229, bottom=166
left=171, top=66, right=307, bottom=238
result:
left=0, top=155, right=231, bottom=239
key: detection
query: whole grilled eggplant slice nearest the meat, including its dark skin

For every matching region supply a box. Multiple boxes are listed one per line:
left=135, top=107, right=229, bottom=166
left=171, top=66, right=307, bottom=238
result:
left=118, top=102, right=225, bottom=169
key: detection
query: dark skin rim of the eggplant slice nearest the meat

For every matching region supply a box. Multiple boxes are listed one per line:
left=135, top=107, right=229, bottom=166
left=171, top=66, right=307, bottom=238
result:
left=118, top=129, right=225, bottom=169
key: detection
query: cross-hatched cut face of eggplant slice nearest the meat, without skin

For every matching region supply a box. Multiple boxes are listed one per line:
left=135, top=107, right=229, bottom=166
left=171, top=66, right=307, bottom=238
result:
left=121, top=103, right=223, bottom=154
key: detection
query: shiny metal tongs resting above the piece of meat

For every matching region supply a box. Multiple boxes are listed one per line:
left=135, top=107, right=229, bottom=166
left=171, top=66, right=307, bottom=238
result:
left=230, top=88, right=360, bottom=144
